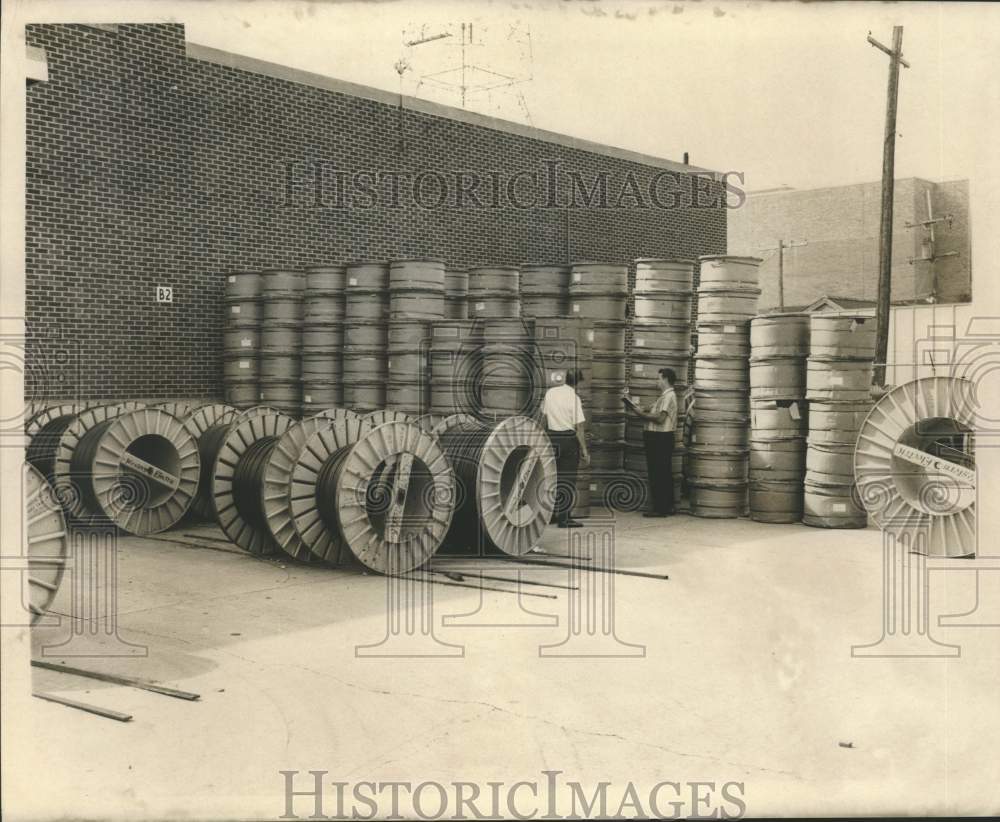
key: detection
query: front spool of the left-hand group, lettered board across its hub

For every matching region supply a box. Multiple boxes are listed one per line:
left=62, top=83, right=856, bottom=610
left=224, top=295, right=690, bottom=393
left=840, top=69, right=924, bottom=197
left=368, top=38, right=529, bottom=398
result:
left=70, top=408, right=200, bottom=536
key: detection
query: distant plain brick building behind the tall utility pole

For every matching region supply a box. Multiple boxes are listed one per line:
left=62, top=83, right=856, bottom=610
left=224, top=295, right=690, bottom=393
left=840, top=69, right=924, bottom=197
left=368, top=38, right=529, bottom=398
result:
left=728, top=177, right=972, bottom=309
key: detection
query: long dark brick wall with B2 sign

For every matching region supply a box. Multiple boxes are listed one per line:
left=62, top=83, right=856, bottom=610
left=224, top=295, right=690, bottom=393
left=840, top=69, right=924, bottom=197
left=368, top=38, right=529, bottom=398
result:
left=27, top=25, right=726, bottom=399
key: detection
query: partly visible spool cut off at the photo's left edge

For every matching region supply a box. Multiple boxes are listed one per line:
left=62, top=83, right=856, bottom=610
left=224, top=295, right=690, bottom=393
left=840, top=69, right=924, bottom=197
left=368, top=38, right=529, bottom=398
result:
left=21, top=463, right=69, bottom=625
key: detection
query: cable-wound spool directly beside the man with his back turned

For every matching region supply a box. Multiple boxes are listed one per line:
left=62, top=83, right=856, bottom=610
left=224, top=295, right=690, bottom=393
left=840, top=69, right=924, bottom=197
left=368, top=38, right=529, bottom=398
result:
left=440, top=417, right=556, bottom=556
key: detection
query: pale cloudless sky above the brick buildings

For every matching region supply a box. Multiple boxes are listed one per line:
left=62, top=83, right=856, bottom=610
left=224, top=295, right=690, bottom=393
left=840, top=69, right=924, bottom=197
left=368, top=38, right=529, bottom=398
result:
left=7, top=0, right=1000, bottom=196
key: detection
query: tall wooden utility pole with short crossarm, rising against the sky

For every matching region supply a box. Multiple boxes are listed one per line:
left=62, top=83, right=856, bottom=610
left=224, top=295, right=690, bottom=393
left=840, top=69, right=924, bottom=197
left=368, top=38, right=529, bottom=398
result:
left=868, top=26, right=910, bottom=394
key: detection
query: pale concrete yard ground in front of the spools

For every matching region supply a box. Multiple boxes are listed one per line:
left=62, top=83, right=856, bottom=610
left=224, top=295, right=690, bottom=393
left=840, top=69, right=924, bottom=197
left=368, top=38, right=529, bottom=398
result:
left=11, top=515, right=1000, bottom=818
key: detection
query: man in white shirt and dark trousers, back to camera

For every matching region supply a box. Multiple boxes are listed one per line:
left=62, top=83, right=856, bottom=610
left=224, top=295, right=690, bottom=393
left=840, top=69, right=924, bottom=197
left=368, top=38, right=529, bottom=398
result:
left=542, top=370, right=590, bottom=528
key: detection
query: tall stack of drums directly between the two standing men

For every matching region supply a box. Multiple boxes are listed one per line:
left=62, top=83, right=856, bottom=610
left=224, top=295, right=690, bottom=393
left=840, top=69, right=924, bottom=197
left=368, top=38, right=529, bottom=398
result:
left=569, top=262, right=628, bottom=507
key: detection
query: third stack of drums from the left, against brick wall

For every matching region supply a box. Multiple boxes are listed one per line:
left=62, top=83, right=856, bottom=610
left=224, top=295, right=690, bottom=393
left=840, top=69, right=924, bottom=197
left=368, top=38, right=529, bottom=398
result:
left=302, top=265, right=347, bottom=416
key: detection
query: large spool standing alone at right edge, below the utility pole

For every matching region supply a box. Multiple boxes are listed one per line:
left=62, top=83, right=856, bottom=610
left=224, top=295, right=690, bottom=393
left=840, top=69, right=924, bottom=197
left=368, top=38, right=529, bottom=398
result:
left=854, top=377, right=980, bottom=557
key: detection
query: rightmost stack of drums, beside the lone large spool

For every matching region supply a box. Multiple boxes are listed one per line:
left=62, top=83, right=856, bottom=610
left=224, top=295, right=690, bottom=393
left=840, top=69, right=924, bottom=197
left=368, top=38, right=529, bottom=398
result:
left=802, top=314, right=875, bottom=528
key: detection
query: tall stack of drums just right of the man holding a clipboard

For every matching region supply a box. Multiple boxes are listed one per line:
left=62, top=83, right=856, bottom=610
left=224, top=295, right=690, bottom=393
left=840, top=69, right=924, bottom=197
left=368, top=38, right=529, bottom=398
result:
left=688, top=256, right=761, bottom=518
